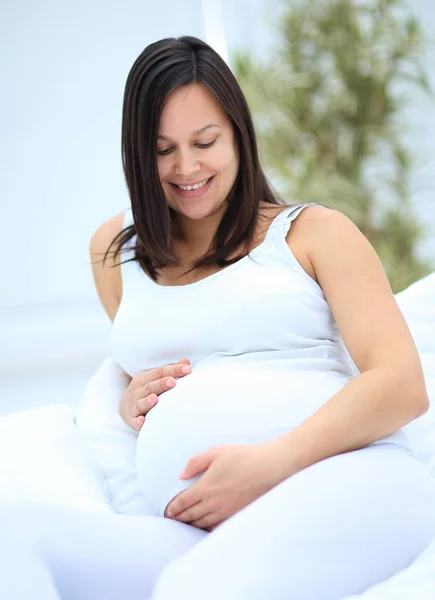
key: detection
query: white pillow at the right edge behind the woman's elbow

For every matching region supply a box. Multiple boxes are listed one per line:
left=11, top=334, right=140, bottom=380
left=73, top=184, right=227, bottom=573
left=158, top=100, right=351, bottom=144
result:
left=396, top=273, right=435, bottom=477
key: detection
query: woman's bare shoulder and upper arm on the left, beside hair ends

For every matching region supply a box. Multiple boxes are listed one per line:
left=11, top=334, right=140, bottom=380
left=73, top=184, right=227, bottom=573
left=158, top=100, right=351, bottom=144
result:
left=89, top=213, right=124, bottom=321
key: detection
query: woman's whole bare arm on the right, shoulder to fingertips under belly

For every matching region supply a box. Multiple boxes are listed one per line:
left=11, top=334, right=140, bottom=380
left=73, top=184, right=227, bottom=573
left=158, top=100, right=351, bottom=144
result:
left=165, top=206, right=428, bottom=530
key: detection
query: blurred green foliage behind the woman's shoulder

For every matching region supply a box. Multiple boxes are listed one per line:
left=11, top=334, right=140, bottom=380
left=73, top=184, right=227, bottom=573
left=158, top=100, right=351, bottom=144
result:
left=237, top=0, right=434, bottom=292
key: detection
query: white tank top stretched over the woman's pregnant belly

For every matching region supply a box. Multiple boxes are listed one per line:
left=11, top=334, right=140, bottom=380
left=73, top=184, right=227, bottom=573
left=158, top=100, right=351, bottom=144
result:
left=111, top=204, right=408, bottom=516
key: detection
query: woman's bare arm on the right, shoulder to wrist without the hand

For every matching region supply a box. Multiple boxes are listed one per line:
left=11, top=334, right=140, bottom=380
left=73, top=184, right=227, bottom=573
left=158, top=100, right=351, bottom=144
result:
left=274, top=207, right=429, bottom=476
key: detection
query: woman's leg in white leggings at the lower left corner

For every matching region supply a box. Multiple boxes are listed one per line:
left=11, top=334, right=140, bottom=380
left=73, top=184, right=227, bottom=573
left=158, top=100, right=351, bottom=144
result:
left=0, top=504, right=208, bottom=600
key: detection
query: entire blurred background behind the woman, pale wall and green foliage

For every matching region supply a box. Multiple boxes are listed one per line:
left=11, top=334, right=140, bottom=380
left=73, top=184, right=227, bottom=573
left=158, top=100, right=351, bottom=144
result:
left=0, top=0, right=435, bottom=414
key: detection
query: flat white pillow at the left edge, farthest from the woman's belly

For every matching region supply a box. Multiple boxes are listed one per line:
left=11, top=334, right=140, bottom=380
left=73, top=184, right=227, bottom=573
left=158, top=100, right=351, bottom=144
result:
left=0, top=405, right=112, bottom=512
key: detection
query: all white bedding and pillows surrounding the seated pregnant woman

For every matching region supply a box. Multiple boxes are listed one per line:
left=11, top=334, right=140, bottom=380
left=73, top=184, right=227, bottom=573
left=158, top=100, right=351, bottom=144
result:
left=0, top=273, right=435, bottom=600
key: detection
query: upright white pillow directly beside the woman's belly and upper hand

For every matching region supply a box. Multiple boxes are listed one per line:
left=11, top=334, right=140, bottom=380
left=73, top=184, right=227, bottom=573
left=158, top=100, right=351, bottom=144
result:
left=76, top=357, right=152, bottom=515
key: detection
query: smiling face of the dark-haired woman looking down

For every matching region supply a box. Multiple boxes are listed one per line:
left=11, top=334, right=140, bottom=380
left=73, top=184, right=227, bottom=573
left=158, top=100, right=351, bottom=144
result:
left=157, top=83, right=239, bottom=220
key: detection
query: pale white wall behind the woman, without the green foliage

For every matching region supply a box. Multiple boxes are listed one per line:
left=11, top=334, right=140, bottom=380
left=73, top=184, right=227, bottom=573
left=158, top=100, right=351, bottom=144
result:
left=0, top=0, right=435, bottom=413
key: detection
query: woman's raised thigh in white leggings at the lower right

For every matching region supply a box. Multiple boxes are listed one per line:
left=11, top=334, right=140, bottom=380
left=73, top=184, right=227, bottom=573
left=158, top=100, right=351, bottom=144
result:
left=152, top=444, right=435, bottom=600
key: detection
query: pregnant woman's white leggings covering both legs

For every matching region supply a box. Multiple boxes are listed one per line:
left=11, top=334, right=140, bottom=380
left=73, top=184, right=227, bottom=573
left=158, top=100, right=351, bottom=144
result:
left=0, top=443, right=435, bottom=600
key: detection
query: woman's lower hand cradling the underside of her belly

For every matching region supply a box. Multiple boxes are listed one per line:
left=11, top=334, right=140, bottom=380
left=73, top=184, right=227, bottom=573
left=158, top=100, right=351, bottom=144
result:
left=165, top=442, right=290, bottom=531
